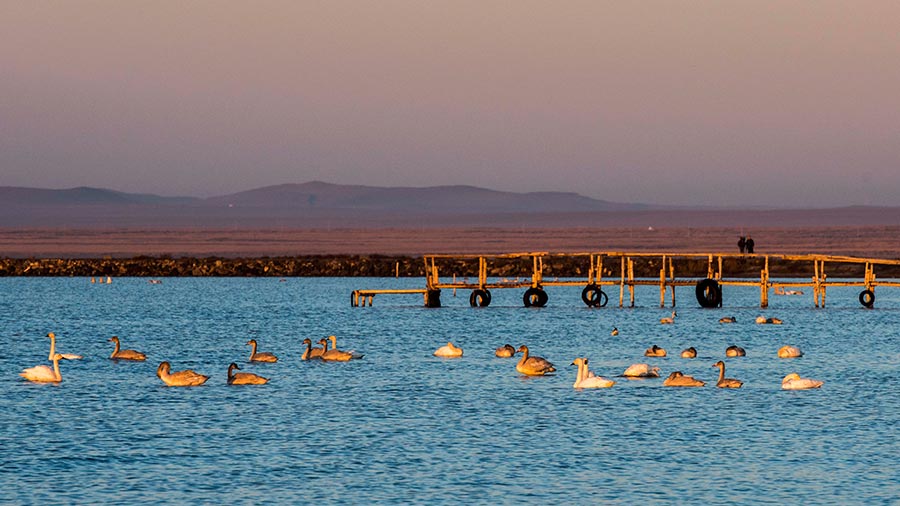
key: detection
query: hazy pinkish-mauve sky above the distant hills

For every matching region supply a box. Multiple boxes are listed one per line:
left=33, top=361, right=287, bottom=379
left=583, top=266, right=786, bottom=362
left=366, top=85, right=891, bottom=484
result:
left=0, top=0, right=900, bottom=207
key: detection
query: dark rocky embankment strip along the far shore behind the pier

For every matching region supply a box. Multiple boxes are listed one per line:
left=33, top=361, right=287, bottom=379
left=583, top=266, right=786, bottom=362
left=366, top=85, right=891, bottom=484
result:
left=0, top=255, right=900, bottom=279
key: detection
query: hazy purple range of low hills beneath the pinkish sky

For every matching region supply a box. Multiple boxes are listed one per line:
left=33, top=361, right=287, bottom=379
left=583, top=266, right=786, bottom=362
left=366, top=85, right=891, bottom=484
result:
left=0, top=181, right=900, bottom=229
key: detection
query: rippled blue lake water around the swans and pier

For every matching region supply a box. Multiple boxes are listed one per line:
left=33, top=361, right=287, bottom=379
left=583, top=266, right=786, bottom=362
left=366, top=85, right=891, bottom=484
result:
left=0, top=278, right=900, bottom=504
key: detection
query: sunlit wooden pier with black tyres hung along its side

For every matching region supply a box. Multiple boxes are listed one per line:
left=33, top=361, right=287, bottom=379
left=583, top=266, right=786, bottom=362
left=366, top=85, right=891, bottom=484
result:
left=350, top=251, right=900, bottom=308
